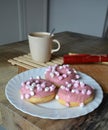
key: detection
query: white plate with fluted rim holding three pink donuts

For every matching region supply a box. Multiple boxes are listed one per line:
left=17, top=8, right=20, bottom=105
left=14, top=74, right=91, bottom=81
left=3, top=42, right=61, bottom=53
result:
left=5, top=68, right=103, bottom=119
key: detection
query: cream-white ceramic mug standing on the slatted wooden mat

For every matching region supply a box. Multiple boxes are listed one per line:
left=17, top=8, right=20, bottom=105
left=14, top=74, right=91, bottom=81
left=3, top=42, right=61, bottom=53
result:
left=28, top=32, right=60, bottom=62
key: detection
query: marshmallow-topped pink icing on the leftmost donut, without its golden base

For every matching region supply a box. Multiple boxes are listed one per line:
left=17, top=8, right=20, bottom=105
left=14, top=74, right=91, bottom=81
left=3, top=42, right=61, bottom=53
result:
left=20, top=78, right=56, bottom=99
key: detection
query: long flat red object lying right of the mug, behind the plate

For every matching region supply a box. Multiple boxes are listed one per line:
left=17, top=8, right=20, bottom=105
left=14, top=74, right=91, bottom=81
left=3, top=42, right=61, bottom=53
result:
left=63, top=54, right=108, bottom=64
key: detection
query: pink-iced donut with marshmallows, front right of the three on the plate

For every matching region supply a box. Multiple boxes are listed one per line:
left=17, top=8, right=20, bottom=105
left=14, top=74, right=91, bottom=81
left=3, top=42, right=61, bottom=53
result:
left=56, top=80, right=94, bottom=107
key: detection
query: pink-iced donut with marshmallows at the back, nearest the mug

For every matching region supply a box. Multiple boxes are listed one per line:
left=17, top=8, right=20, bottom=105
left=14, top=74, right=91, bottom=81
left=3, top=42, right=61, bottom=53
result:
left=45, top=65, right=80, bottom=87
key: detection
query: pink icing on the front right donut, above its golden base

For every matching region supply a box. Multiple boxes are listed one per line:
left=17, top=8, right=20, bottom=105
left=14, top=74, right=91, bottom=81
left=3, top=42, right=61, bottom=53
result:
left=57, top=81, right=94, bottom=106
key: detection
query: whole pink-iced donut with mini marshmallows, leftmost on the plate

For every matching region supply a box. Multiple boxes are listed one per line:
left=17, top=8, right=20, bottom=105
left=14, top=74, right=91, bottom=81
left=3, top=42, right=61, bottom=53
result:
left=20, top=76, right=56, bottom=104
